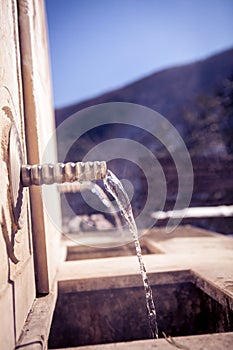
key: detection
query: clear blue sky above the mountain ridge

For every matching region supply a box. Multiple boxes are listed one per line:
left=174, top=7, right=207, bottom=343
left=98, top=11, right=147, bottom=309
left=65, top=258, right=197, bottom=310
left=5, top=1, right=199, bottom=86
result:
left=46, top=0, right=233, bottom=107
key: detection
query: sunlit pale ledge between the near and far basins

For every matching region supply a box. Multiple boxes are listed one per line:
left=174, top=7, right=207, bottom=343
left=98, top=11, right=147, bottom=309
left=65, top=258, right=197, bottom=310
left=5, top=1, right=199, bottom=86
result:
left=58, top=226, right=233, bottom=297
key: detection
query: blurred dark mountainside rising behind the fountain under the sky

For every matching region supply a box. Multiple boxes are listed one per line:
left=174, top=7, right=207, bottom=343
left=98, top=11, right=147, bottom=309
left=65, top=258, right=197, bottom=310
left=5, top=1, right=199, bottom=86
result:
left=55, top=49, right=233, bottom=233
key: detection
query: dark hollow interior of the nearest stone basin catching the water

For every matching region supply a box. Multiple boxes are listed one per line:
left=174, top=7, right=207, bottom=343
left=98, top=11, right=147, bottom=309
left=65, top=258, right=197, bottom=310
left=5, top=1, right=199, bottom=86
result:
left=49, top=270, right=233, bottom=349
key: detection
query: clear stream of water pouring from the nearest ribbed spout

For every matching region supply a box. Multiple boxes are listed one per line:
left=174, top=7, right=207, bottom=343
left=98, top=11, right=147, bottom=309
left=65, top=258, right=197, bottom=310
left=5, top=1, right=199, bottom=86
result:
left=103, top=170, right=158, bottom=338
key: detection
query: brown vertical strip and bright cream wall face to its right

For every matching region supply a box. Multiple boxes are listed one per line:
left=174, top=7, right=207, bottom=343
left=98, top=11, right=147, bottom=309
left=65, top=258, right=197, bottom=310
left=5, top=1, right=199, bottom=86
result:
left=18, top=0, right=60, bottom=293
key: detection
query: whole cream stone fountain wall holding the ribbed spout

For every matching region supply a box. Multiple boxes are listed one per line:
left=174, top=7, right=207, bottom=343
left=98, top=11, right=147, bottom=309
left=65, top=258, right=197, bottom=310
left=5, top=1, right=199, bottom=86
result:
left=0, top=0, right=60, bottom=350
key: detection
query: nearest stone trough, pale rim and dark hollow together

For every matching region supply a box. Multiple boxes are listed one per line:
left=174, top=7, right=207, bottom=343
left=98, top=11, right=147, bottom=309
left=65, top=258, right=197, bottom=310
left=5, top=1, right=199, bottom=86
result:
left=46, top=226, right=233, bottom=350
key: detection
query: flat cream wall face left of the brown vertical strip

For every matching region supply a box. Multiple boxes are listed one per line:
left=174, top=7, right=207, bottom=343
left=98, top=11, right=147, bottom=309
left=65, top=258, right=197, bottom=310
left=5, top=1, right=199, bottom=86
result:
left=0, top=0, right=35, bottom=350
